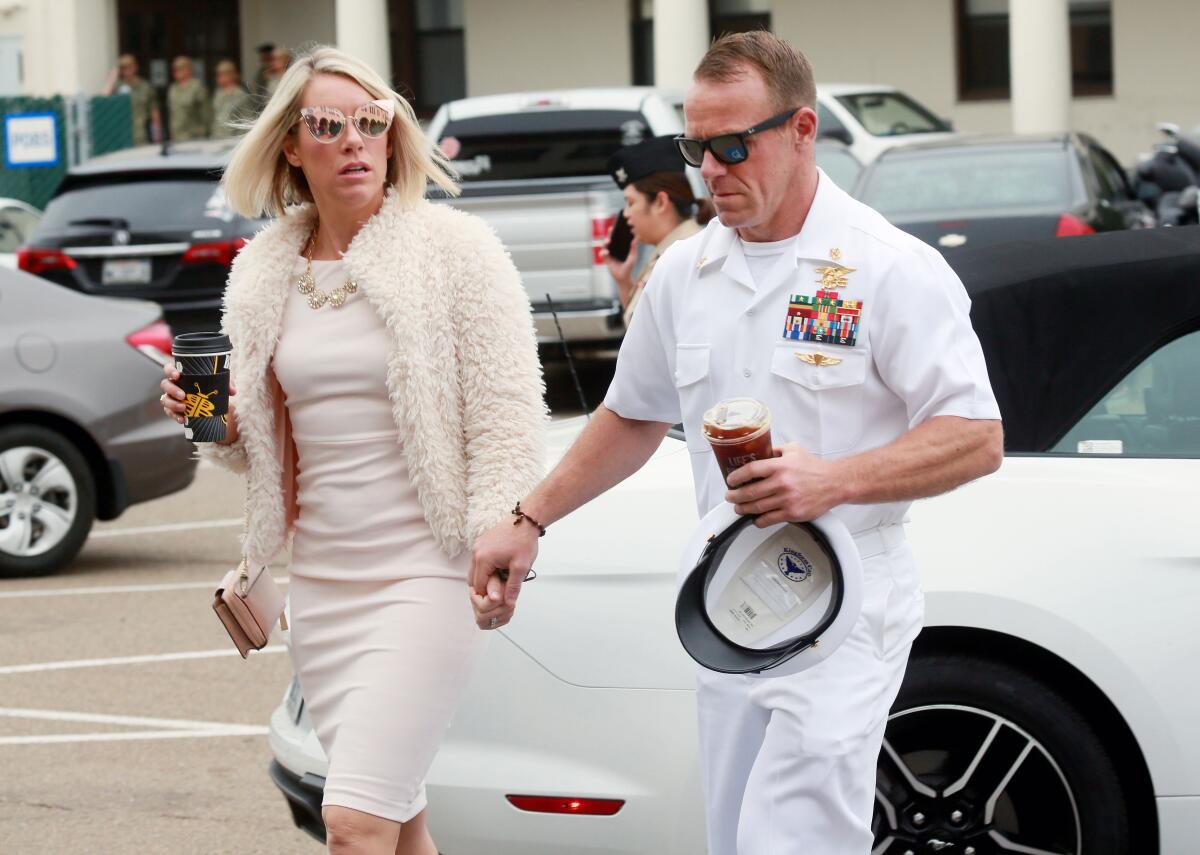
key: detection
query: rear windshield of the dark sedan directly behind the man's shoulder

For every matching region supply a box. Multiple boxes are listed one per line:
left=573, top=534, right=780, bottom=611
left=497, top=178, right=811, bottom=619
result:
left=859, top=147, right=1070, bottom=215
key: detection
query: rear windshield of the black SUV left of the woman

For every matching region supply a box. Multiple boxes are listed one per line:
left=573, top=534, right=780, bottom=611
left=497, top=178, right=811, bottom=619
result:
left=37, top=175, right=236, bottom=234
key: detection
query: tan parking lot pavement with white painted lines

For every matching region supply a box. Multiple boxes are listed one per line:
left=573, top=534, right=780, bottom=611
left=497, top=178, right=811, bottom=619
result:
left=0, top=364, right=611, bottom=855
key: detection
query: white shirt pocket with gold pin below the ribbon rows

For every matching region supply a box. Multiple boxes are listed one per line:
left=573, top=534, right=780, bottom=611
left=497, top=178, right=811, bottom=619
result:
left=770, top=342, right=869, bottom=454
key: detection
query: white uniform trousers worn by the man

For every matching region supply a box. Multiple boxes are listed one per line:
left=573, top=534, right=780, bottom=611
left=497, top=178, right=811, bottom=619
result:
left=696, top=526, right=924, bottom=855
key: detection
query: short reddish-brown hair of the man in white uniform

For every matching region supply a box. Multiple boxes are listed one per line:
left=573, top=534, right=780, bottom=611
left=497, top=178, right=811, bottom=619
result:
left=692, top=30, right=817, bottom=112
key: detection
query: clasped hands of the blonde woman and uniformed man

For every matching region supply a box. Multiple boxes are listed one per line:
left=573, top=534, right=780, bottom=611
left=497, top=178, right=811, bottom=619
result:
left=467, top=519, right=538, bottom=629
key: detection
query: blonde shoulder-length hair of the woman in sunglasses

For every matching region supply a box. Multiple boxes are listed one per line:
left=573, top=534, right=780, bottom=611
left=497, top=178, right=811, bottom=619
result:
left=222, top=44, right=458, bottom=217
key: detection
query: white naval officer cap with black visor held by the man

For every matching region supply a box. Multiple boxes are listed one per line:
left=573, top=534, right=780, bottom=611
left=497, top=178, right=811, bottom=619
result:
left=676, top=503, right=863, bottom=677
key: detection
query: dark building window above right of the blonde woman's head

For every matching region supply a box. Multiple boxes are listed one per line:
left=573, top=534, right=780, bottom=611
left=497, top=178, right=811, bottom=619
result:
left=388, top=0, right=467, bottom=116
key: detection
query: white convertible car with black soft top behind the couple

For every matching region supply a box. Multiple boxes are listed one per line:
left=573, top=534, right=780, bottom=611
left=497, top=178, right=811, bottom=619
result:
left=270, top=228, right=1200, bottom=855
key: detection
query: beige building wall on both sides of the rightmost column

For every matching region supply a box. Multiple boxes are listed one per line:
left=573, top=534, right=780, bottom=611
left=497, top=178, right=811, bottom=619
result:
left=772, top=0, right=1200, bottom=165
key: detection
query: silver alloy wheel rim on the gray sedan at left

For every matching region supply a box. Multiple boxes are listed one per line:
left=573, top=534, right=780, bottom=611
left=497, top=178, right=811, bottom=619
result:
left=0, top=446, right=79, bottom=558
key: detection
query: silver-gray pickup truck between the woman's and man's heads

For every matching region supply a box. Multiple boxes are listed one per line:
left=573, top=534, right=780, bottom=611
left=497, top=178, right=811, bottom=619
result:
left=427, top=86, right=683, bottom=347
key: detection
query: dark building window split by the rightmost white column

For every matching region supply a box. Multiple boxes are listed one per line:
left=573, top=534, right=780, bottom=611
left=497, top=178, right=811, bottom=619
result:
left=955, top=0, right=1112, bottom=101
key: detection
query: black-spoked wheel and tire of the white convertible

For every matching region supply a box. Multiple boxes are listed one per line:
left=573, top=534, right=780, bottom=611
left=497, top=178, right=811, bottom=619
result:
left=872, top=656, right=1130, bottom=855
